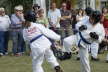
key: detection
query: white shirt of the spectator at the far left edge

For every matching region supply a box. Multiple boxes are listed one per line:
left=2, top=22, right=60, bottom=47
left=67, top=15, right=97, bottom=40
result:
left=0, top=15, right=11, bottom=31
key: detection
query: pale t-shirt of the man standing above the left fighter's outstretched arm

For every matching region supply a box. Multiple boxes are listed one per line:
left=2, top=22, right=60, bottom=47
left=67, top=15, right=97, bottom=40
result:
left=48, top=9, right=61, bottom=28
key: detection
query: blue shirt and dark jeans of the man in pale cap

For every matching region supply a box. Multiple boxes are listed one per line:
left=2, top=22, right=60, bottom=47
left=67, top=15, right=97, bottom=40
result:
left=10, top=14, right=25, bottom=54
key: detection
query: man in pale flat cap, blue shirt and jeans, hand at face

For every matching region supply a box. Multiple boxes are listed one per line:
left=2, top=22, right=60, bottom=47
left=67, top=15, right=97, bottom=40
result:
left=10, top=5, right=25, bottom=56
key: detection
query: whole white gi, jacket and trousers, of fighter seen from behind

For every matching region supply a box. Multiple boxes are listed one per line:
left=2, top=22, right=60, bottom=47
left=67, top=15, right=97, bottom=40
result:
left=23, top=22, right=60, bottom=72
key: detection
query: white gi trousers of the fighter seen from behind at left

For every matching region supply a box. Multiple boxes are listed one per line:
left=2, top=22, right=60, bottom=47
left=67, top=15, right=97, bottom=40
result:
left=31, top=46, right=59, bottom=72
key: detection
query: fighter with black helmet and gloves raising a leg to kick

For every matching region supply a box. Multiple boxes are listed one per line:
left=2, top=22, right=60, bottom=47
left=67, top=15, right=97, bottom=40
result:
left=60, top=11, right=105, bottom=72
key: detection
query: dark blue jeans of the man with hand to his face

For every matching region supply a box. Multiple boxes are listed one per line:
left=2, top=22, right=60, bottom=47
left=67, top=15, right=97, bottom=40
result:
left=11, top=30, right=25, bottom=54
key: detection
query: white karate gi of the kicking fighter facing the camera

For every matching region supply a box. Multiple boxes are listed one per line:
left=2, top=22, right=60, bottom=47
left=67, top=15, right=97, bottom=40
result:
left=63, top=20, right=105, bottom=72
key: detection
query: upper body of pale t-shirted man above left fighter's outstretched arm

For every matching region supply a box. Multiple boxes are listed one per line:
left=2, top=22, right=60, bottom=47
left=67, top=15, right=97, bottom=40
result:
left=48, top=3, right=61, bottom=33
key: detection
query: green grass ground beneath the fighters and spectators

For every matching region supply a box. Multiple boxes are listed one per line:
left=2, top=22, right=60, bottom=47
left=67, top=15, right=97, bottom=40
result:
left=0, top=51, right=108, bottom=72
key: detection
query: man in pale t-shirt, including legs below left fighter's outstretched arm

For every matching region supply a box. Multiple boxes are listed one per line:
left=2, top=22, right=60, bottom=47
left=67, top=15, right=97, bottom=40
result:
left=48, top=3, right=61, bottom=56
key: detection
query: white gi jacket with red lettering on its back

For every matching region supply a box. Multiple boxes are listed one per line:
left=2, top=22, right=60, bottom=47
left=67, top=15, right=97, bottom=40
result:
left=23, top=23, right=60, bottom=48
